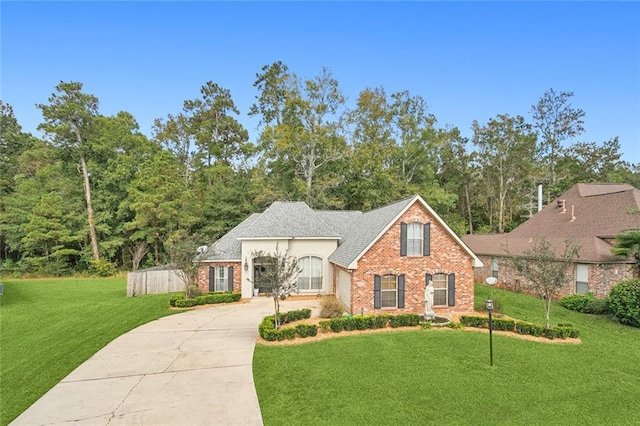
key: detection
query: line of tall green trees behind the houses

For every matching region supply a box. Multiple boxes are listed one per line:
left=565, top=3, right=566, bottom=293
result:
left=0, top=62, right=640, bottom=275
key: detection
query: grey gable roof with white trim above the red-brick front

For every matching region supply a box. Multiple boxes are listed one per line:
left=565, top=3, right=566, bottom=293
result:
left=329, top=195, right=482, bottom=269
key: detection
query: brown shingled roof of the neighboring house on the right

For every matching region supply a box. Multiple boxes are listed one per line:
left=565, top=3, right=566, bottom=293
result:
left=463, top=183, right=640, bottom=262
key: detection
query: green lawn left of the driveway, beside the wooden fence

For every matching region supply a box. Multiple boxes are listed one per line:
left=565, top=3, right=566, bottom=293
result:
left=0, top=278, right=176, bottom=425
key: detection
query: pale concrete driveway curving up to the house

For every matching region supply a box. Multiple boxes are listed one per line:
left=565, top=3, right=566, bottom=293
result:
left=11, top=297, right=319, bottom=426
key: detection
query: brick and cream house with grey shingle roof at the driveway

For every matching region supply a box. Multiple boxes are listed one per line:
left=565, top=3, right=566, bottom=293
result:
left=195, top=196, right=482, bottom=314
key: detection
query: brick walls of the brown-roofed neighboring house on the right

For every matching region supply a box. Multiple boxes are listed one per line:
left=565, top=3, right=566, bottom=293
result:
left=475, top=256, right=634, bottom=298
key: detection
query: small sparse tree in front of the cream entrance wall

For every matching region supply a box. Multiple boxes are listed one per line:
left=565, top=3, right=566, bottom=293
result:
left=252, top=245, right=299, bottom=330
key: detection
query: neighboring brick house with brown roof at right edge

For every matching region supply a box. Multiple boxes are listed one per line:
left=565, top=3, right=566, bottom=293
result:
left=463, top=183, right=640, bottom=297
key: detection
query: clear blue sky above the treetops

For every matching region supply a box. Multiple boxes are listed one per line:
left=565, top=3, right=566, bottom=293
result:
left=0, top=1, right=640, bottom=163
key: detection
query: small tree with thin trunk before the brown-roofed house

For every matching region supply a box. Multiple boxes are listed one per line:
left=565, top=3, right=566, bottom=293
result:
left=509, top=238, right=580, bottom=328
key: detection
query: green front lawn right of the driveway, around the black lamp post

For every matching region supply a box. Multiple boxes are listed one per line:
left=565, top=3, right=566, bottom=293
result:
left=253, top=285, right=640, bottom=425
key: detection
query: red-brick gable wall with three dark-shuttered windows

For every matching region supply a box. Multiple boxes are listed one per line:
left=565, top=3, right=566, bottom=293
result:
left=351, top=203, right=473, bottom=314
